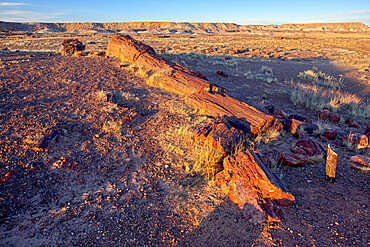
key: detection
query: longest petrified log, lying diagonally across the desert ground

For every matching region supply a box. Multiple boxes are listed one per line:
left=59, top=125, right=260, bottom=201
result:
left=107, top=35, right=282, bottom=136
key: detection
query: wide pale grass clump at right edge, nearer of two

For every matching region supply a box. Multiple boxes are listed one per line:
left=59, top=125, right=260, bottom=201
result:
left=290, top=83, right=370, bottom=118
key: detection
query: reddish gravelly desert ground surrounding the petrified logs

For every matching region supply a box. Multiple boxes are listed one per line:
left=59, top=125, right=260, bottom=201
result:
left=0, top=31, right=370, bottom=246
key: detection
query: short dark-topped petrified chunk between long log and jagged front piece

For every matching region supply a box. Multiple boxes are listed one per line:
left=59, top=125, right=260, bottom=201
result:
left=193, top=119, right=244, bottom=156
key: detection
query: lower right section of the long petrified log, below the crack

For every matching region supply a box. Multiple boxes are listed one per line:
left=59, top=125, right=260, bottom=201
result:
left=185, top=92, right=283, bottom=135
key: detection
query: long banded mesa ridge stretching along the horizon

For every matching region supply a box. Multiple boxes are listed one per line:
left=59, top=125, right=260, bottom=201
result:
left=0, top=21, right=370, bottom=33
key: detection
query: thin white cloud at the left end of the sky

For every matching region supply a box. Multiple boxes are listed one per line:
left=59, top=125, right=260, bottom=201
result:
left=0, top=10, right=64, bottom=22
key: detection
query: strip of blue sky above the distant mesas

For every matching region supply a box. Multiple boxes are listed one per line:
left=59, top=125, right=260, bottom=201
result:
left=0, top=0, right=370, bottom=25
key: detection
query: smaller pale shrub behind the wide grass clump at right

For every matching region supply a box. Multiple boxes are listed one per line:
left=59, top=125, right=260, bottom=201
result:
left=297, top=70, right=342, bottom=89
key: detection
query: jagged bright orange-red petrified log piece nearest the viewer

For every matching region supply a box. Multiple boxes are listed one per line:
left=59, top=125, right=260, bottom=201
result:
left=214, top=150, right=295, bottom=223
